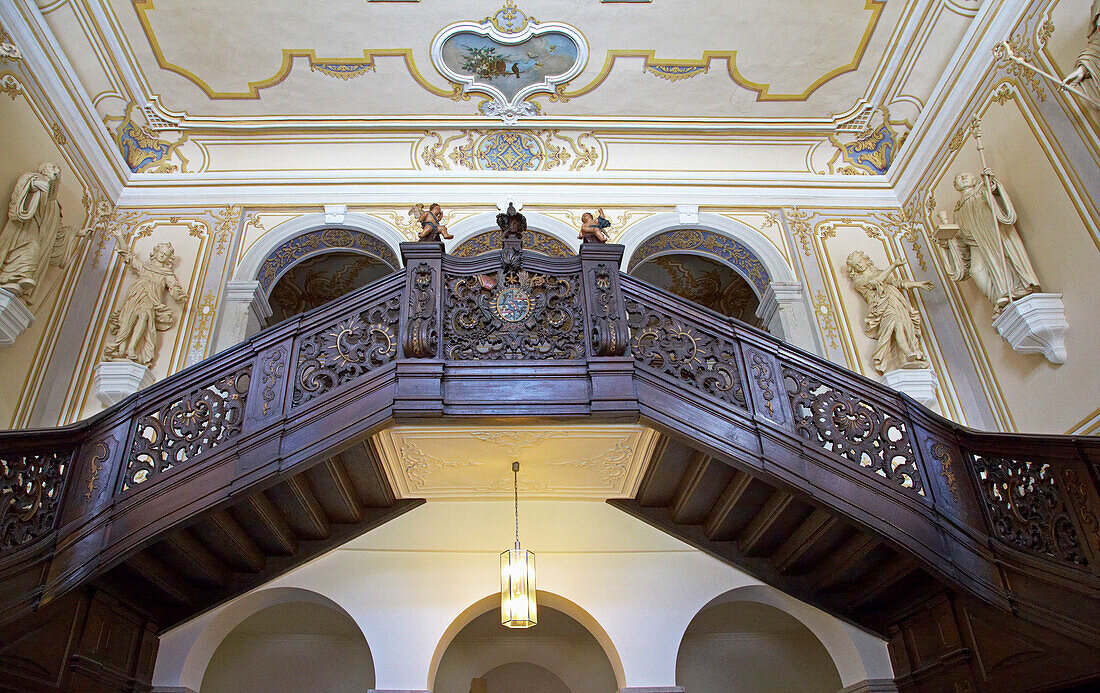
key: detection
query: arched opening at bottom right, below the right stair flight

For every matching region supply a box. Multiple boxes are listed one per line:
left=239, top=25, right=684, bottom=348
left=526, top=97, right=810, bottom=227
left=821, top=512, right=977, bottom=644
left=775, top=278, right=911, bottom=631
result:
left=677, top=598, right=843, bottom=693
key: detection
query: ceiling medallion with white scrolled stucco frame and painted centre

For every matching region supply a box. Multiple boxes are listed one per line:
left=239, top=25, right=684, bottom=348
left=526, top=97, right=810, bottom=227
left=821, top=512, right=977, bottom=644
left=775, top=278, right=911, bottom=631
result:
left=431, top=0, right=589, bottom=125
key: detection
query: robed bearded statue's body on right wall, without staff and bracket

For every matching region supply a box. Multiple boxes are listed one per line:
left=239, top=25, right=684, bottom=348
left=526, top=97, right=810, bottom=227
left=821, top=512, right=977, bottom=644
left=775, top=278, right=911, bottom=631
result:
left=936, top=168, right=1040, bottom=317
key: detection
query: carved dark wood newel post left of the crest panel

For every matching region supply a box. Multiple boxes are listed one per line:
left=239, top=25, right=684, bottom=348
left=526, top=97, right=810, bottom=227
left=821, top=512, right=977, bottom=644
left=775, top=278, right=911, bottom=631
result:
left=394, top=242, right=443, bottom=417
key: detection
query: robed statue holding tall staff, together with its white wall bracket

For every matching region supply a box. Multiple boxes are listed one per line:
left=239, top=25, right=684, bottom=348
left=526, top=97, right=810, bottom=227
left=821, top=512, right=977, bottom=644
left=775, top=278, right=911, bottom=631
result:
left=935, top=118, right=1068, bottom=363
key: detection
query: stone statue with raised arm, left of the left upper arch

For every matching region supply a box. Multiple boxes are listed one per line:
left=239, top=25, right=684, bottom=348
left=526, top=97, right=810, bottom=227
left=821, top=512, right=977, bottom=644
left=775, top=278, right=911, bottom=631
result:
left=103, top=241, right=187, bottom=366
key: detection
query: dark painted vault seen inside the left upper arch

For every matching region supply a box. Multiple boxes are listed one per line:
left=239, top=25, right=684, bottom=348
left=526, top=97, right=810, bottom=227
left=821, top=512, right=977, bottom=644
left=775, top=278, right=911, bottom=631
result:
left=267, top=253, right=393, bottom=325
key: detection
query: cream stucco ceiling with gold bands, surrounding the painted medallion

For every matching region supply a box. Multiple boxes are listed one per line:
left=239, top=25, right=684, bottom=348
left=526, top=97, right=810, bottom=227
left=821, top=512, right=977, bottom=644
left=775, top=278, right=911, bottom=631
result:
left=40, top=0, right=919, bottom=119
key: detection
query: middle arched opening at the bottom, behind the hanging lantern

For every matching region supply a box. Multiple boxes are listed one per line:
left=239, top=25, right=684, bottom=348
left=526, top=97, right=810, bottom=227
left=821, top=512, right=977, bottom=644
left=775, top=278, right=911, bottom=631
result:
left=432, top=604, right=618, bottom=693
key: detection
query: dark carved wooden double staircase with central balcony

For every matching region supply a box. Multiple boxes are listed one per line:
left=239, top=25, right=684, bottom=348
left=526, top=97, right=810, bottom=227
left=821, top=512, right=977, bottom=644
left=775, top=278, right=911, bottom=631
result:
left=0, top=239, right=1100, bottom=691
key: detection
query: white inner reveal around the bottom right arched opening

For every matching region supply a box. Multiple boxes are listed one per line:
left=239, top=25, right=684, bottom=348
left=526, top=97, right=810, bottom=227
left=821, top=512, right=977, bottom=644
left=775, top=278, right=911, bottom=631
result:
left=677, top=584, right=894, bottom=688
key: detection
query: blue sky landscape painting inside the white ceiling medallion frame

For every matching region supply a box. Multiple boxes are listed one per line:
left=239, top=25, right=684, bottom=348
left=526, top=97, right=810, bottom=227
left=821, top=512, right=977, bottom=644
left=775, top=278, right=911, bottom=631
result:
left=442, top=32, right=578, bottom=100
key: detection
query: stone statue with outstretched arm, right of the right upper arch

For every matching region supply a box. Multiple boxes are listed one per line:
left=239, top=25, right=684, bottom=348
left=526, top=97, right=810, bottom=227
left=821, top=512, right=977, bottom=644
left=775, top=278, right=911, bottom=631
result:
left=847, top=251, right=932, bottom=373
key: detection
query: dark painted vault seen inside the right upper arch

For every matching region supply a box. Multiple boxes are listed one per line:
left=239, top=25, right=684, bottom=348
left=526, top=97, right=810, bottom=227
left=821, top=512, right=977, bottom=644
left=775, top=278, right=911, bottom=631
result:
left=630, top=255, right=760, bottom=326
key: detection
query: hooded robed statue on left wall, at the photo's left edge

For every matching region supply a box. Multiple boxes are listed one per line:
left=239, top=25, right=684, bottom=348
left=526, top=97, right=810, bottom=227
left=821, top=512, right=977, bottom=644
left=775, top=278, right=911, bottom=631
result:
left=0, top=163, right=87, bottom=305
